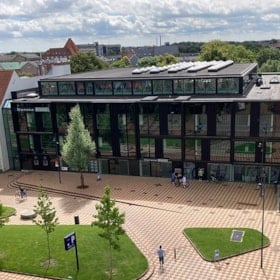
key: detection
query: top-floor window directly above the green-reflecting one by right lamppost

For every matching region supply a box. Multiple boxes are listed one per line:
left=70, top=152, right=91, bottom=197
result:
left=235, top=102, right=250, bottom=136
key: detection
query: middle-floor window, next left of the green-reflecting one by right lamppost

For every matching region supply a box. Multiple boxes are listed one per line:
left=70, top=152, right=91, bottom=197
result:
left=210, top=140, right=230, bottom=161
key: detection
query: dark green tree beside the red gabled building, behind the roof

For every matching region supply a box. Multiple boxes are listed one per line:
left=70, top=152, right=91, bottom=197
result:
left=70, top=52, right=108, bottom=73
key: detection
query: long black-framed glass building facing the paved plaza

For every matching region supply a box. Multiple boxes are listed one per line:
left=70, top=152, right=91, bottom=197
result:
left=4, top=61, right=280, bottom=182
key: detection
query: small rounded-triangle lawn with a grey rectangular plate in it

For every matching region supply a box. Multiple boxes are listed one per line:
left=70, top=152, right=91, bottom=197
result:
left=184, top=228, right=269, bottom=261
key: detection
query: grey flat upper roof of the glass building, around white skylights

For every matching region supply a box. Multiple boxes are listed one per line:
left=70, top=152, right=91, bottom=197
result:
left=41, top=63, right=257, bottom=81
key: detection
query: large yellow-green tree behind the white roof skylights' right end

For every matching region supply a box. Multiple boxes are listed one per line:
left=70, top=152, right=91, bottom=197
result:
left=198, top=40, right=255, bottom=62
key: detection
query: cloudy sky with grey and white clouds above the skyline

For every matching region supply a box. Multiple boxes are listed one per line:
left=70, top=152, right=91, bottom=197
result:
left=0, top=0, right=280, bottom=52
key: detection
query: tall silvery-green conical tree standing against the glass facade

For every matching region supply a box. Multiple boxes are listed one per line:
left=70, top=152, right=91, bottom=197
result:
left=61, top=105, right=95, bottom=188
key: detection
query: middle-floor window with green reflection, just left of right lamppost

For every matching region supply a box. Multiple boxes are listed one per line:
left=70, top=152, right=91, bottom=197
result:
left=234, top=141, right=256, bottom=162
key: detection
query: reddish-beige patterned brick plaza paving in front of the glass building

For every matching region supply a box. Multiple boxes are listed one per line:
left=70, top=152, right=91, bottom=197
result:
left=0, top=171, right=280, bottom=280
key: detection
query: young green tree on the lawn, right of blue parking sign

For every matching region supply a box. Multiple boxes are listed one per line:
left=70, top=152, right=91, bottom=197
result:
left=91, top=186, right=125, bottom=279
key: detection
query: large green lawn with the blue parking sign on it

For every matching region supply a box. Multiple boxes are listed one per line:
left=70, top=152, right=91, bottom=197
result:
left=0, top=225, right=148, bottom=280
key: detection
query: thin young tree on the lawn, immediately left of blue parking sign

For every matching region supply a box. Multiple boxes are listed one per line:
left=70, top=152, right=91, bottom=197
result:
left=33, top=186, right=58, bottom=265
